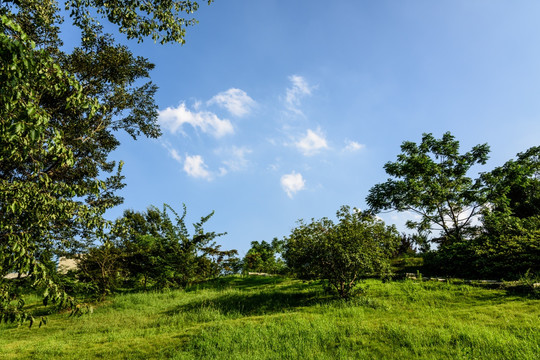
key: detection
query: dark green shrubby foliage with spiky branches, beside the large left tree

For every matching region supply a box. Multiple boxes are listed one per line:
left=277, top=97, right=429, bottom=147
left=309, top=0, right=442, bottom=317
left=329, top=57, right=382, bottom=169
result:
left=111, top=204, right=237, bottom=288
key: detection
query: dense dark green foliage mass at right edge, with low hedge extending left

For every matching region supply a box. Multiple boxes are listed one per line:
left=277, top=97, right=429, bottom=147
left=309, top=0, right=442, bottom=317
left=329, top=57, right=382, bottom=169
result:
left=425, top=147, right=540, bottom=280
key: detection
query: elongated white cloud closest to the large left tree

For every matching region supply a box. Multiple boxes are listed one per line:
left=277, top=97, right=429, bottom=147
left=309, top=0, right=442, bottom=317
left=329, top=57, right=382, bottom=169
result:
left=159, top=103, right=234, bottom=138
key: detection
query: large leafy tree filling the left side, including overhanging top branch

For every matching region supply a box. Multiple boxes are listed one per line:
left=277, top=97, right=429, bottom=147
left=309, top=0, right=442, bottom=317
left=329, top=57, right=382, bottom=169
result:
left=0, top=0, right=214, bottom=320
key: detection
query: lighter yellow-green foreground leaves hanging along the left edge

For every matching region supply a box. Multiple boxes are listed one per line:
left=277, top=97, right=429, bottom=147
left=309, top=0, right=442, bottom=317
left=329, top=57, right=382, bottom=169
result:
left=0, top=15, right=98, bottom=321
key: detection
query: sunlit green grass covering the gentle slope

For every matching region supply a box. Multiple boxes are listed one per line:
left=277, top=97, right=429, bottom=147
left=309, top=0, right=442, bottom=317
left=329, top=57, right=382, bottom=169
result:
left=0, top=277, right=540, bottom=360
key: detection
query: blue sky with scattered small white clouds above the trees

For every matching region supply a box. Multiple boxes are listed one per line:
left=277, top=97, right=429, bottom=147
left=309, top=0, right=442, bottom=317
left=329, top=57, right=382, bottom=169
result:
left=81, top=0, right=540, bottom=255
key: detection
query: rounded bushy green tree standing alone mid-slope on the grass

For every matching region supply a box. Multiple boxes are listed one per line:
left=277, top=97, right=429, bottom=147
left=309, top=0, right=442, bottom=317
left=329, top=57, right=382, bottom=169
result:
left=284, top=206, right=400, bottom=298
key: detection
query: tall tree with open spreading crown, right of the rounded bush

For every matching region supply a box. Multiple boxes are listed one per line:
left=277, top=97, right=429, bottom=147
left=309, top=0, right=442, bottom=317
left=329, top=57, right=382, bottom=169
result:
left=366, top=132, right=489, bottom=245
